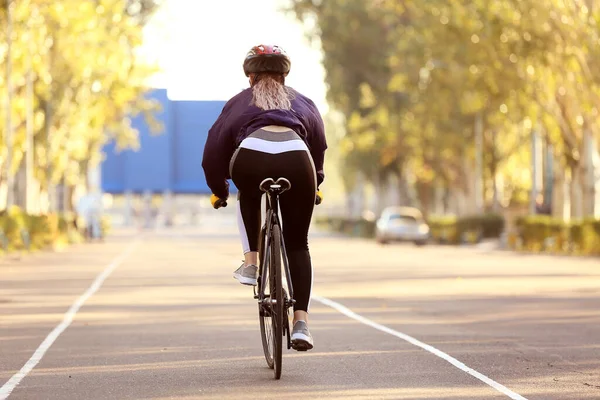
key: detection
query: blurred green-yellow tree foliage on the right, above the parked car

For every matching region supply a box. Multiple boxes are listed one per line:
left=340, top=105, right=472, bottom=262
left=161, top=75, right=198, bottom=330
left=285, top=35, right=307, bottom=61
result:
left=293, top=0, right=600, bottom=214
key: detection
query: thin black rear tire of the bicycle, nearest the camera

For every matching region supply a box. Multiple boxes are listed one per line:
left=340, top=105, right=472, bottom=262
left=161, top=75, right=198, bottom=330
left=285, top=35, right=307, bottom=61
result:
left=269, top=225, right=287, bottom=379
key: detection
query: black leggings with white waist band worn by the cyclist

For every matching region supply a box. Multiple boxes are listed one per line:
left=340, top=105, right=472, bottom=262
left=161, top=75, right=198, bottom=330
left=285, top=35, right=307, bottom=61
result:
left=230, top=129, right=316, bottom=311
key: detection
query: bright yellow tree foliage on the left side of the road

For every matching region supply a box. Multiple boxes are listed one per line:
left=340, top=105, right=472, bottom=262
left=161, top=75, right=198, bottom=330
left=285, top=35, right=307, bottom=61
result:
left=0, top=0, right=160, bottom=212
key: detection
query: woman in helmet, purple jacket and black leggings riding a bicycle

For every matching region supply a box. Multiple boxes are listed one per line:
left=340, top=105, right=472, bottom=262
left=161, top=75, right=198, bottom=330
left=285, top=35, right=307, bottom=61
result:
left=202, top=45, right=327, bottom=350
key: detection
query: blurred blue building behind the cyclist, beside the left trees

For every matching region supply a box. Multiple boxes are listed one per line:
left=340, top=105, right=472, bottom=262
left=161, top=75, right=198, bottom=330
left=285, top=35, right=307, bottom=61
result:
left=101, top=89, right=225, bottom=194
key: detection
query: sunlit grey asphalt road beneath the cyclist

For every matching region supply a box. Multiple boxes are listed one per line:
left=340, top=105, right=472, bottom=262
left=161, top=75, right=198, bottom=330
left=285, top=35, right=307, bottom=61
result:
left=0, top=220, right=600, bottom=400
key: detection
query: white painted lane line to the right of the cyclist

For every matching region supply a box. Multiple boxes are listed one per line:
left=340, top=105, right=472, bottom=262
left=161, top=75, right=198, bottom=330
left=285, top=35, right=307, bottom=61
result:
left=312, top=296, right=527, bottom=400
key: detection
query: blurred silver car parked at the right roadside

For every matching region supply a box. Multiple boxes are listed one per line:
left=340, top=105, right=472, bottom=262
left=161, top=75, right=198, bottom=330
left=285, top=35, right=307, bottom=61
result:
left=375, top=207, right=430, bottom=246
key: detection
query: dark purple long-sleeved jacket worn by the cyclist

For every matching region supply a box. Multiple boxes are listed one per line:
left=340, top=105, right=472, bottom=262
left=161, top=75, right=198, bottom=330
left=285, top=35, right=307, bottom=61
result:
left=202, top=88, right=327, bottom=199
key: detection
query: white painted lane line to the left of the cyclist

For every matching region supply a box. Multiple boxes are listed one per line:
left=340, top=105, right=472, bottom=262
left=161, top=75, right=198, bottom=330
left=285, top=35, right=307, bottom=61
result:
left=0, top=239, right=142, bottom=400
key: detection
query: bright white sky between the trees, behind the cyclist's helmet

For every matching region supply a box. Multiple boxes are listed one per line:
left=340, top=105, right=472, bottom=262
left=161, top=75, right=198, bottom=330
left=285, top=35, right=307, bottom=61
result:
left=143, top=0, right=328, bottom=114
